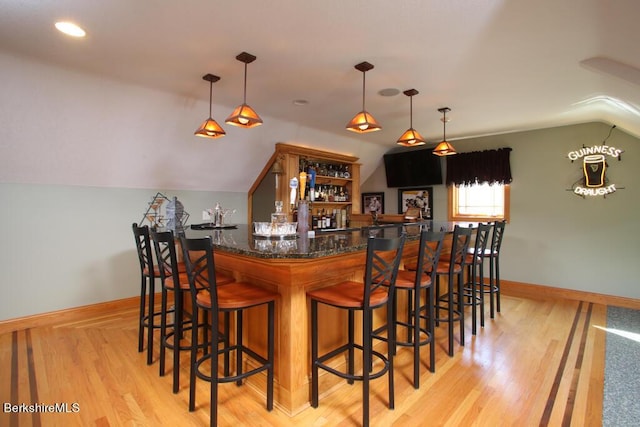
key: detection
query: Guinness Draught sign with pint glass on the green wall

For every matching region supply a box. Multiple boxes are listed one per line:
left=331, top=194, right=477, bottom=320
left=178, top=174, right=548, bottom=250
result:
left=568, top=145, right=622, bottom=197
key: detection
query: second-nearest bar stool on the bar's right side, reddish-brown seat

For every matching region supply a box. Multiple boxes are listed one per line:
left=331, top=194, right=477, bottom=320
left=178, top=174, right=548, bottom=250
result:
left=375, top=229, right=444, bottom=389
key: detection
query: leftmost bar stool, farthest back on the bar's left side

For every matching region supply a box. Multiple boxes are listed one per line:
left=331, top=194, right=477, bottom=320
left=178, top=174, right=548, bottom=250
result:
left=131, top=222, right=160, bottom=365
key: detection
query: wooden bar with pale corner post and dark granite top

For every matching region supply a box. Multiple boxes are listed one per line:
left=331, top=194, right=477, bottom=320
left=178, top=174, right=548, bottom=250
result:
left=186, top=221, right=453, bottom=415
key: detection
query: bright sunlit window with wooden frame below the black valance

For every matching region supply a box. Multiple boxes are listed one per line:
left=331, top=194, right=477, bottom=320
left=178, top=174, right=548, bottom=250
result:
left=449, top=182, right=510, bottom=221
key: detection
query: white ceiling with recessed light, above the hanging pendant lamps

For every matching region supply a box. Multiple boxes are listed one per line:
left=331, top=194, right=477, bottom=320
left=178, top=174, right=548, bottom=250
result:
left=0, top=0, right=640, bottom=147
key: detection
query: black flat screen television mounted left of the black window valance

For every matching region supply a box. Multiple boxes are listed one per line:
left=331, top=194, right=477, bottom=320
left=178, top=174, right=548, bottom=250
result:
left=383, top=149, right=442, bottom=187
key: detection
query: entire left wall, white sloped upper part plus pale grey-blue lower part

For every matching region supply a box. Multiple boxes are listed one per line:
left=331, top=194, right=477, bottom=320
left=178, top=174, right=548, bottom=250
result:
left=0, top=53, right=384, bottom=321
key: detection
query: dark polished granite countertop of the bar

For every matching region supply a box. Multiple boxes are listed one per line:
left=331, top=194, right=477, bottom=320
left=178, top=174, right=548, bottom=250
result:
left=185, top=221, right=469, bottom=259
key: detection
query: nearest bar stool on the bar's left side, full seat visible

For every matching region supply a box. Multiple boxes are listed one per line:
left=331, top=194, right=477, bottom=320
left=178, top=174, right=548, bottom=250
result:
left=180, top=236, right=278, bottom=426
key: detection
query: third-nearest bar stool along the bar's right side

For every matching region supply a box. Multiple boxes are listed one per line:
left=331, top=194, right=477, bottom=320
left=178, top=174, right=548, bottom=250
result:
left=435, top=225, right=473, bottom=357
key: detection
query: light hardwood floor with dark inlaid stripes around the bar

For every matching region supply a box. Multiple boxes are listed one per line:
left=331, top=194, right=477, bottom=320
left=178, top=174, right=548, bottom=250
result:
left=0, top=294, right=606, bottom=426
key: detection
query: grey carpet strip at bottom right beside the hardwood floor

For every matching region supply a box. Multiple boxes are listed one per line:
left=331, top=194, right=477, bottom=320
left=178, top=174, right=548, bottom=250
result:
left=602, top=307, right=640, bottom=427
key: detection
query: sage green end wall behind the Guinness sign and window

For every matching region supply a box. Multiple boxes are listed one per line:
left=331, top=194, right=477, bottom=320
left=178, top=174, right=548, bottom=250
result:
left=362, top=123, right=640, bottom=298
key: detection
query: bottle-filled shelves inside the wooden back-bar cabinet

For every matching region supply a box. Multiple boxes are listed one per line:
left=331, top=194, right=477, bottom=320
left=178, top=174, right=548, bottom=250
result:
left=298, top=157, right=352, bottom=230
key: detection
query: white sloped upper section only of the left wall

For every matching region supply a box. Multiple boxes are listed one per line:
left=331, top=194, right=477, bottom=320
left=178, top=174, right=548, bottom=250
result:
left=0, top=53, right=385, bottom=193
